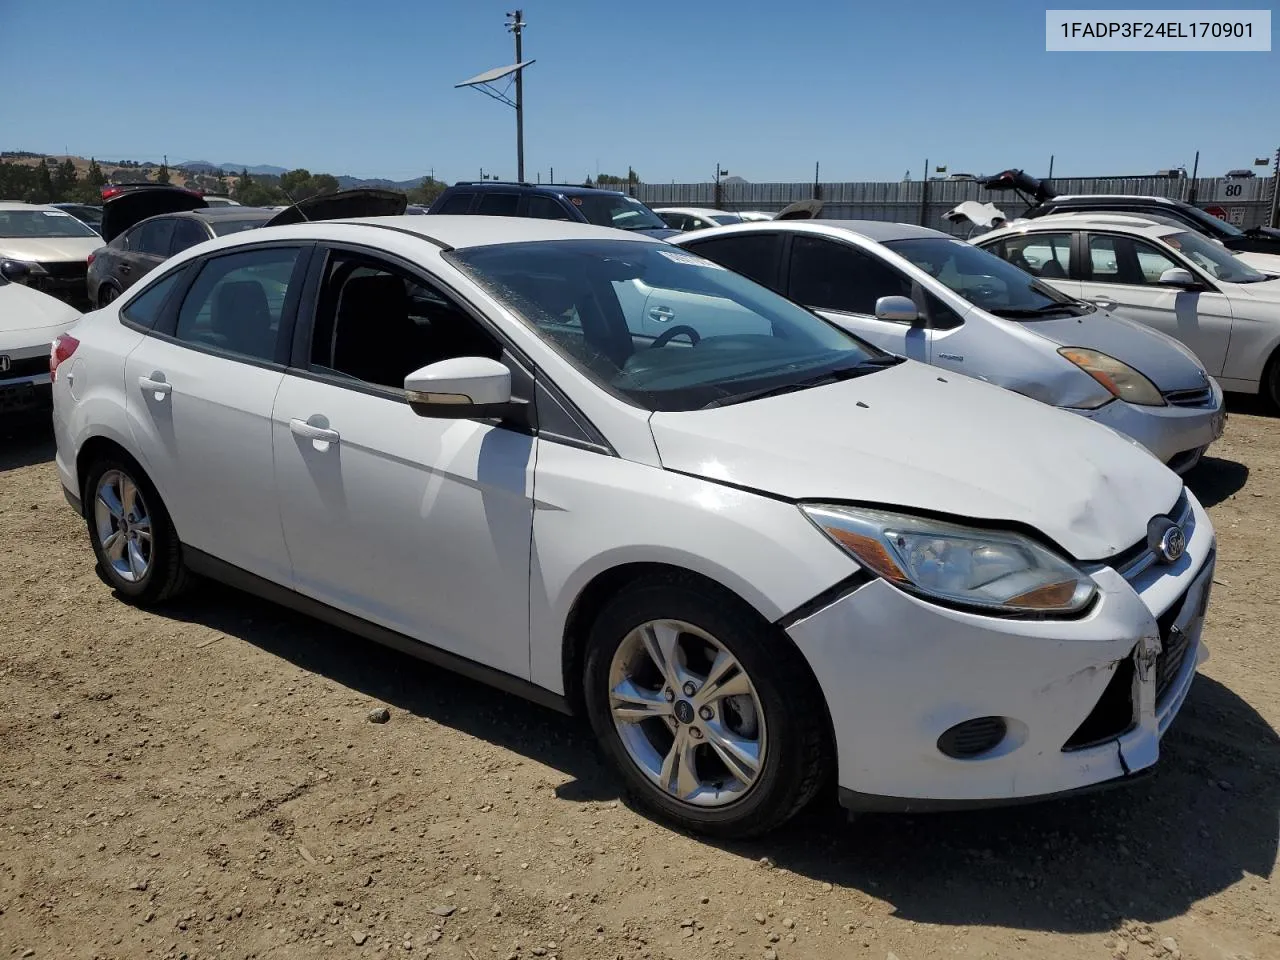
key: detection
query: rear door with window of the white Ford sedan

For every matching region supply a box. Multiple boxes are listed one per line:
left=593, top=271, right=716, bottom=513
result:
left=124, top=244, right=310, bottom=584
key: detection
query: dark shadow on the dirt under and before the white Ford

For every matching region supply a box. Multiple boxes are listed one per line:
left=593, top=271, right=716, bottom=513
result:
left=154, top=585, right=1280, bottom=932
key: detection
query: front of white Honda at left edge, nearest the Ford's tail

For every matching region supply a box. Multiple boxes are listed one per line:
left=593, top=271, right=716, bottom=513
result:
left=0, top=266, right=81, bottom=417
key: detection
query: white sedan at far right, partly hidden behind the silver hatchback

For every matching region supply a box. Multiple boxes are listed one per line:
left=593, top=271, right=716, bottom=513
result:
left=973, top=214, right=1280, bottom=407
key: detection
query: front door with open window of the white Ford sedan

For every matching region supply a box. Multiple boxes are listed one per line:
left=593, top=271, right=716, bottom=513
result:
left=271, top=250, right=538, bottom=677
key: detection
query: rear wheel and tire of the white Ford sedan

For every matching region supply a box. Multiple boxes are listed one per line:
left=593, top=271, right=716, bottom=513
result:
left=84, top=457, right=187, bottom=607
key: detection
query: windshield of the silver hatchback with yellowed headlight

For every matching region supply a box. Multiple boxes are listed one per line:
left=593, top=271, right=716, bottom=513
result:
left=884, top=237, right=1082, bottom=320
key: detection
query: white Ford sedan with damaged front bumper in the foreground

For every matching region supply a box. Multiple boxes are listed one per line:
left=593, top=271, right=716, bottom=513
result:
left=54, top=215, right=1215, bottom=836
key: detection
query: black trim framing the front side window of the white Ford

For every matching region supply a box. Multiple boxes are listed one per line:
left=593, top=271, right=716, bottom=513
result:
left=284, top=234, right=617, bottom=457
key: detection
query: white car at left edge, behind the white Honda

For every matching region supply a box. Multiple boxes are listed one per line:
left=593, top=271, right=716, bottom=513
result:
left=0, top=201, right=102, bottom=306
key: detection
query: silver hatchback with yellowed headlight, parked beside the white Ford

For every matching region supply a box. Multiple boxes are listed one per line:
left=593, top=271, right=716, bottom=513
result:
left=675, top=220, right=1226, bottom=472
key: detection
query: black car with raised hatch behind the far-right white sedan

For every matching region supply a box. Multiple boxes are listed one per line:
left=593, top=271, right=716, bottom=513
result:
left=979, top=170, right=1280, bottom=253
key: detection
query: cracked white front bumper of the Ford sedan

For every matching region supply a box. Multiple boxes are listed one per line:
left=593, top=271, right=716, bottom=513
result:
left=788, top=495, right=1215, bottom=810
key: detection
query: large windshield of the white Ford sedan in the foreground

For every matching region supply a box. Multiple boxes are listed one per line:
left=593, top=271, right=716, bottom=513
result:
left=445, top=241, right=892, bottom=411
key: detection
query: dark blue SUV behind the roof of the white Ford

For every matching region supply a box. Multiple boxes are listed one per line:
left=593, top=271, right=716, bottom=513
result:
left=426, top=180, right=680, bottom=238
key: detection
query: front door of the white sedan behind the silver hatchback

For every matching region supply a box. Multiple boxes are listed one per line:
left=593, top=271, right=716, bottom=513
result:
left=1079, top=233, right=1231, bottom=376
